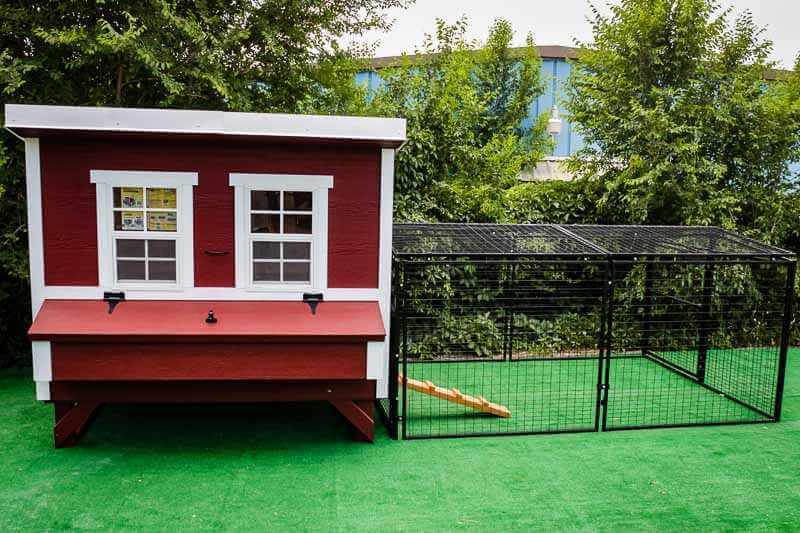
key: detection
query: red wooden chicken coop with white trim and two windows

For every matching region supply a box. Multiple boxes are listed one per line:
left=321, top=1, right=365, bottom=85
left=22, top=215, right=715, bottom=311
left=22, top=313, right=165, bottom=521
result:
left=5, top=105, right=405, bottom=446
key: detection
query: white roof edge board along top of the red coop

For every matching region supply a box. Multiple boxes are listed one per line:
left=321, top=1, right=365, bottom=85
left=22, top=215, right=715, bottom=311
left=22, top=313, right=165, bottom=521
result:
left=5, top=104, right=406, bottom=146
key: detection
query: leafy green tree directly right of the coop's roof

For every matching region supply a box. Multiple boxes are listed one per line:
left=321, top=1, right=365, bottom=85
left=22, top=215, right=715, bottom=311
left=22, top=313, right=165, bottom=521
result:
left=371, top=19, right=550, bottom=221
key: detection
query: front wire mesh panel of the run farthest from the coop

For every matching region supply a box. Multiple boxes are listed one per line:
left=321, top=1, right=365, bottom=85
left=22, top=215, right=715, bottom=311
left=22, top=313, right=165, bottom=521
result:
left=604, top=258, right=788, bottom=429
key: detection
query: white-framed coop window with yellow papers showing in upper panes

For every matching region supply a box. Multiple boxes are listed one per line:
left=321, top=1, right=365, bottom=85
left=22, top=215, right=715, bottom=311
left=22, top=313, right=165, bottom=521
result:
left=92, top=171, right=197, bottom=289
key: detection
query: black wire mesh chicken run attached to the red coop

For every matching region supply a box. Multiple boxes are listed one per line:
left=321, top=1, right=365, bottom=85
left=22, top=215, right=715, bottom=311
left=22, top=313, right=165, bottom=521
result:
left=382, top=224, right=796, bottom=439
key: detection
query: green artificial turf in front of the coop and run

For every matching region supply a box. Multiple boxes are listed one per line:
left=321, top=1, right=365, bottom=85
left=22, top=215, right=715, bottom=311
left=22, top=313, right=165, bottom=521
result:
left=0, top=350, right=800, bottom=531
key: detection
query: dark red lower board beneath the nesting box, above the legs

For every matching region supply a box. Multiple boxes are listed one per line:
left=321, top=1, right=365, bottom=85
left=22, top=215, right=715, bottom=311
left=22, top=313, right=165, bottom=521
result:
left=50, top=379, right=375, bottom=403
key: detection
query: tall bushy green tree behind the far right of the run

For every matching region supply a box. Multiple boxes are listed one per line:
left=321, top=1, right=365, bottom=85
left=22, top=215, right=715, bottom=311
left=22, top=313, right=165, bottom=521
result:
left=567, top=0, right=800, bottom=238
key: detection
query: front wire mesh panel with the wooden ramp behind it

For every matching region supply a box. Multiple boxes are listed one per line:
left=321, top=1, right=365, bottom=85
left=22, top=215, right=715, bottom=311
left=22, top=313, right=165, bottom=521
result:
left=396, top=257, right=606, bottom=438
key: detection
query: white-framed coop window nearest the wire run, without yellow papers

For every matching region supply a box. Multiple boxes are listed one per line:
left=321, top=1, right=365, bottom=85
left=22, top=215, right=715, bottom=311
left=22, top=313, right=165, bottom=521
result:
left=231, top=174, right=333, bottom=290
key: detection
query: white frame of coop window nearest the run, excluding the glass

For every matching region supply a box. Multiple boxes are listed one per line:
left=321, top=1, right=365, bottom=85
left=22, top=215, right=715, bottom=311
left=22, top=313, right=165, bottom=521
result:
left=229, top=173, right=333, bottom=292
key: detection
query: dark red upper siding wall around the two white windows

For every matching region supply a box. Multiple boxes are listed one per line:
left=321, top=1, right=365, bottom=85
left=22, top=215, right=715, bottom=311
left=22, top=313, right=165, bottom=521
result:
left=40, top=135, right=380, bottom=288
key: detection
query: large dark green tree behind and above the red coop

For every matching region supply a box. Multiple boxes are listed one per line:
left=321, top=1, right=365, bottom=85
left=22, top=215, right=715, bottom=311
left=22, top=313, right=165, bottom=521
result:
left=0, top=0, right=410, bottom=366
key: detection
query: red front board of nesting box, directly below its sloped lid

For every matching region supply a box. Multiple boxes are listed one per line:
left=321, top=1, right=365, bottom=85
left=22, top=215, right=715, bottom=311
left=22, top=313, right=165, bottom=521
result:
left=52, top=342, right=367, bottom=381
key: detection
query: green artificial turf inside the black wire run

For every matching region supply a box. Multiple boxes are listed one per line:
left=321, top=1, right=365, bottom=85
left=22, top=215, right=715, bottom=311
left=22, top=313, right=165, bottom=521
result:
left=405, top=348, right=777, bottom=437
